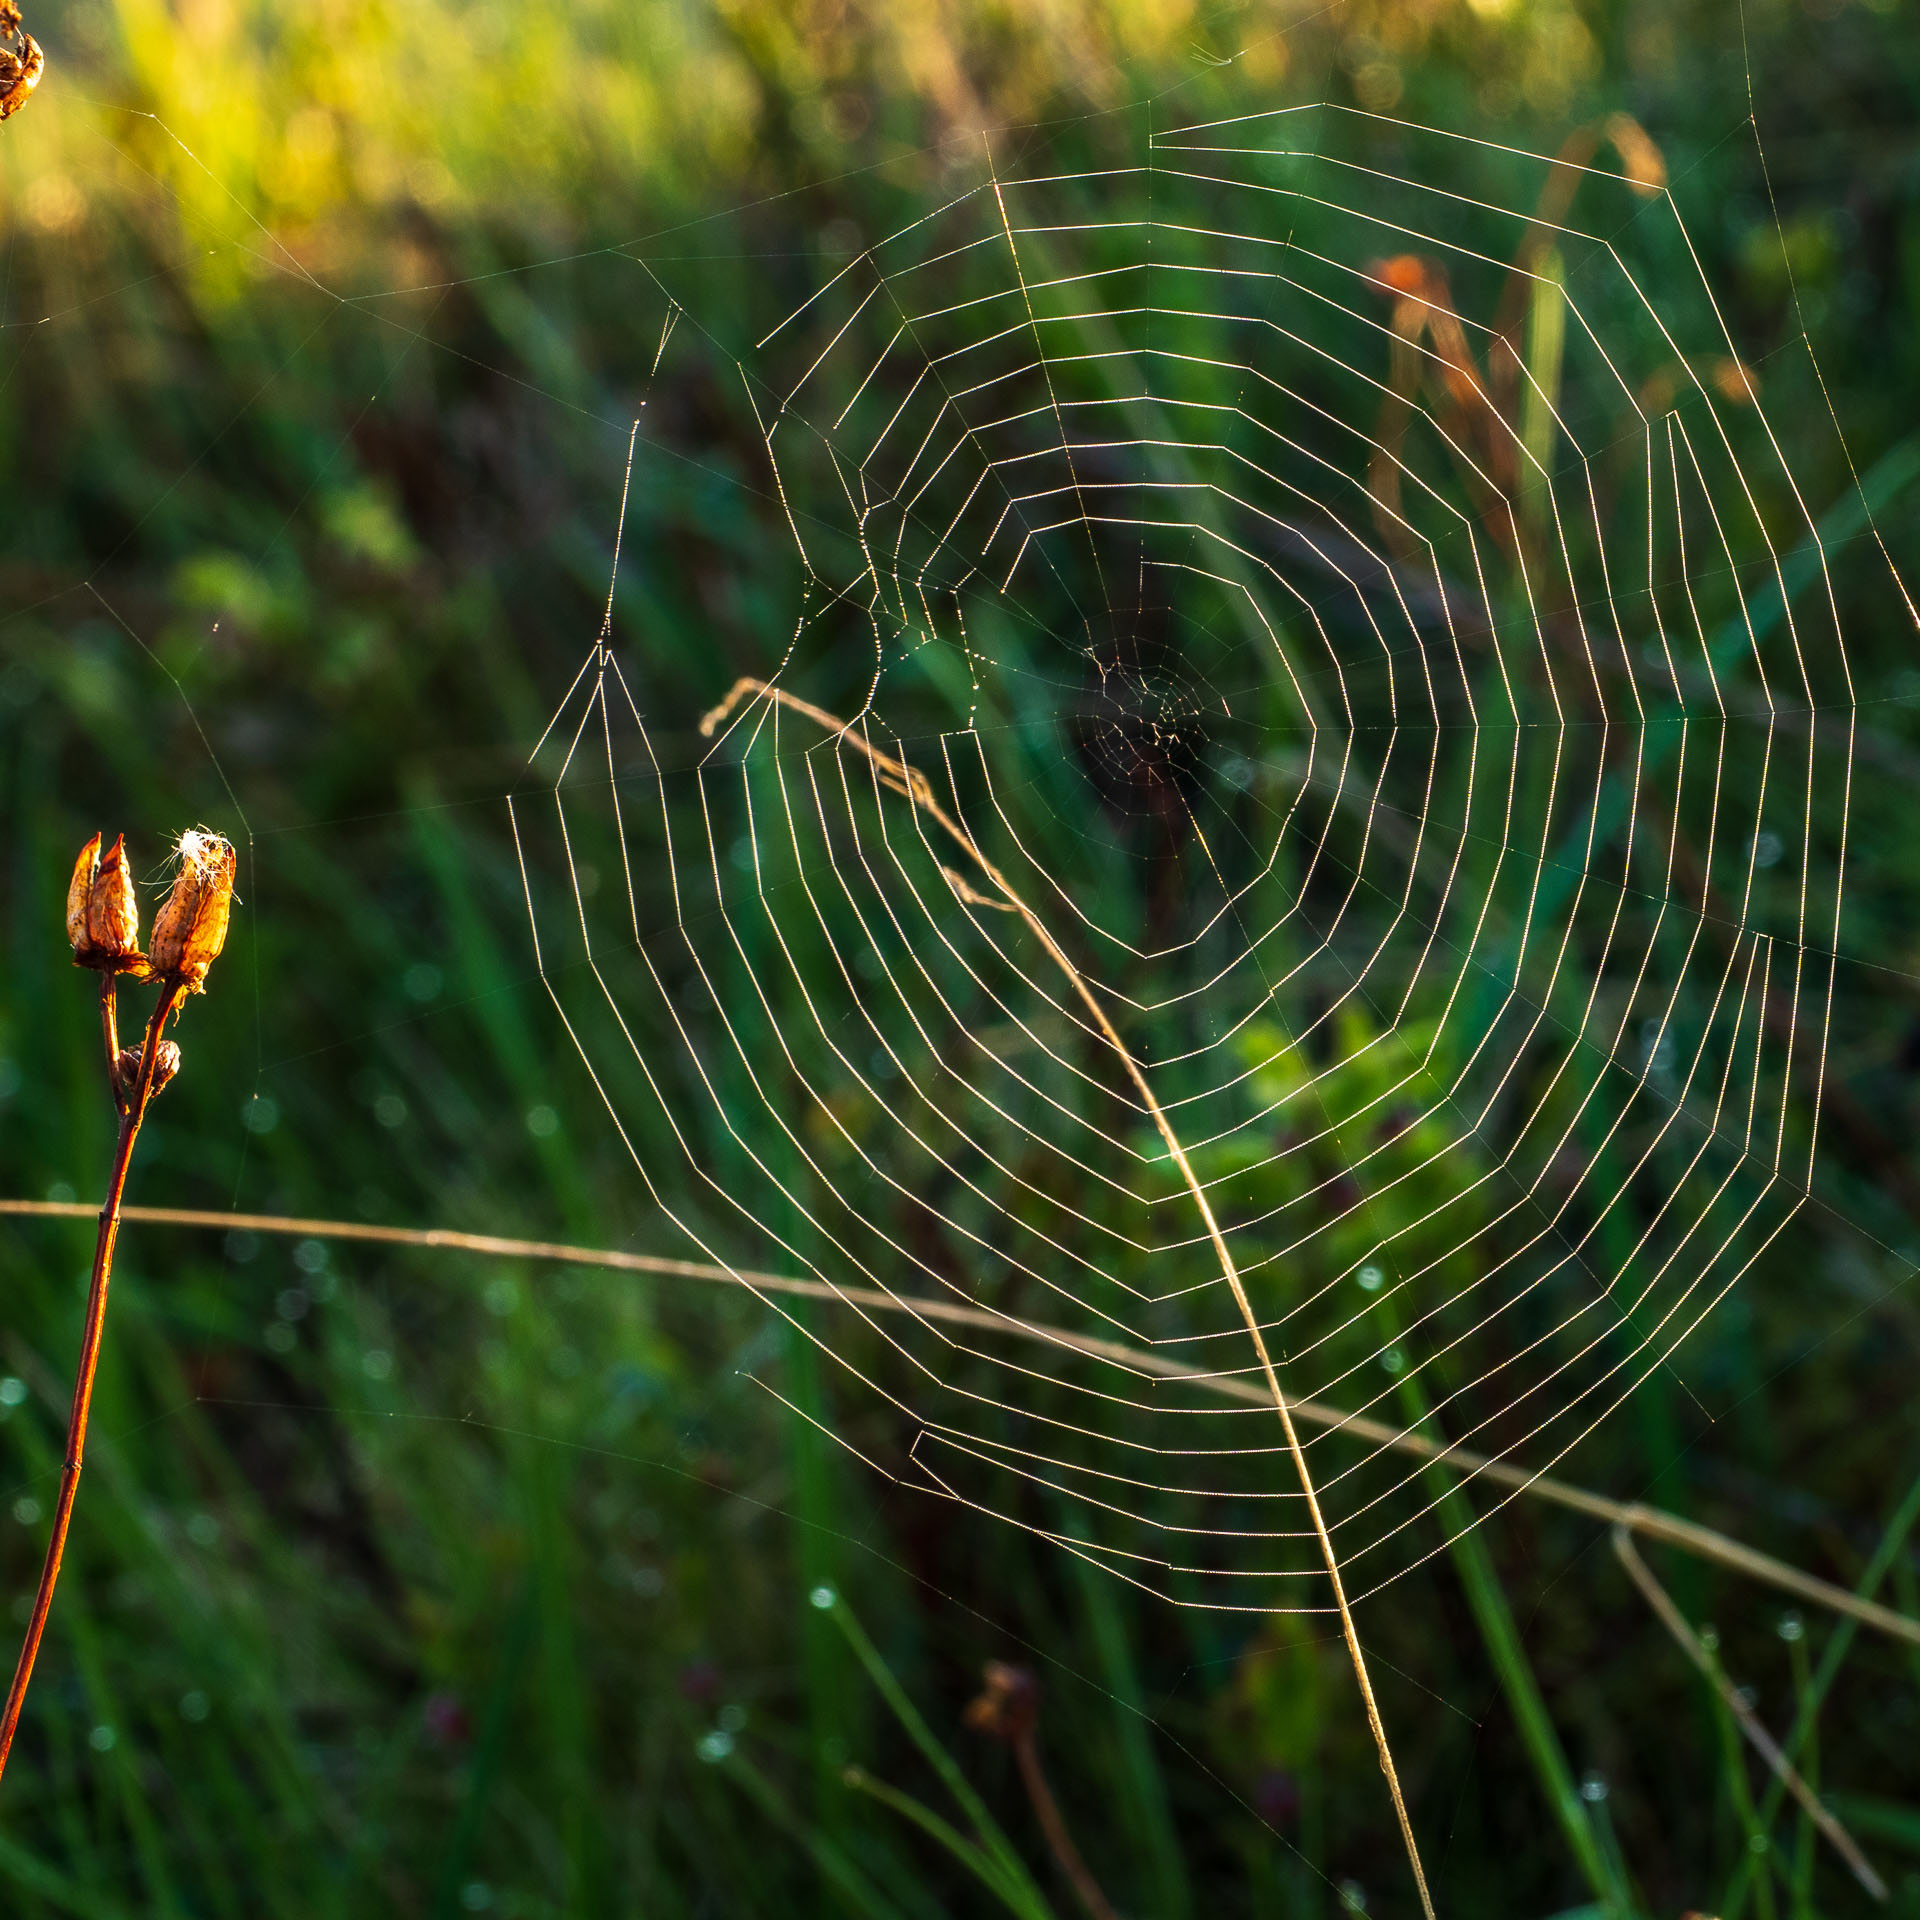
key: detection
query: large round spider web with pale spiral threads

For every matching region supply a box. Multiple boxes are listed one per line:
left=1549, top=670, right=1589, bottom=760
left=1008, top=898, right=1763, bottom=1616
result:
left=515, top=106, right=1853, bottom=1611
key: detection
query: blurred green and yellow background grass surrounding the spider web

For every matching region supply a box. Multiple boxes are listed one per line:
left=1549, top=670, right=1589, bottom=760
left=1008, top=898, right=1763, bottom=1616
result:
left=0, top=0, right=1920, bottom=1916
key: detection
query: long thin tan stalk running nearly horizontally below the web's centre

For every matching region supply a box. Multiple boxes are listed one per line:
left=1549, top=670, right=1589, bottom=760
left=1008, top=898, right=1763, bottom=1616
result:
left=0, top=1200, right=1920, bottom=1647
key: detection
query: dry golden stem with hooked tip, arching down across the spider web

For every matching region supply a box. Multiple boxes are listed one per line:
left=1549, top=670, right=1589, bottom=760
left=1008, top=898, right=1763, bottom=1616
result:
left=701, top=678, right=1434, bottom=1920
